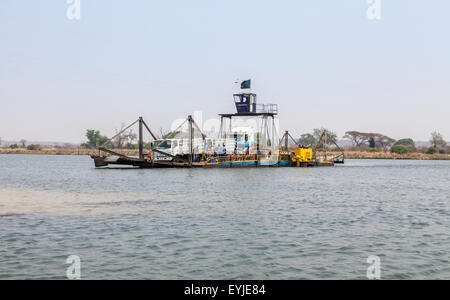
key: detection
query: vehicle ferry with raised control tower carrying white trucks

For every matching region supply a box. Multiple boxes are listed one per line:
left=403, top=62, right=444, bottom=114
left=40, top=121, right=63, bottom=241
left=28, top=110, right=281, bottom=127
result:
left=91, top=87, right=344, bottom=168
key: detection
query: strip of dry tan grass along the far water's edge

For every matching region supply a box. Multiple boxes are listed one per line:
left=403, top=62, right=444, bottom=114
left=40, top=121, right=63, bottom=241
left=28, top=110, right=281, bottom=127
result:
left=0, top=148, right=450, bottom=160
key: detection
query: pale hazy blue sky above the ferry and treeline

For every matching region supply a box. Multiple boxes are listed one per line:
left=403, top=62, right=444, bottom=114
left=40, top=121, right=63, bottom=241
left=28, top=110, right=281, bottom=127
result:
left=0, top=0, right=450, bottom=143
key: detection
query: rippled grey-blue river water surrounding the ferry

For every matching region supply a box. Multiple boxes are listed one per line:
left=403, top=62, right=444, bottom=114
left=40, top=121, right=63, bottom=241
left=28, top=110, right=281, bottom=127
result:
left=0, top=155, right=450, bottom=279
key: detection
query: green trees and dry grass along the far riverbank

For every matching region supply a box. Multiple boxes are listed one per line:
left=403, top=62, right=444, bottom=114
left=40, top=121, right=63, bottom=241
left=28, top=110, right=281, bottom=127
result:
left=0, top=126, right=450, bottom=160
